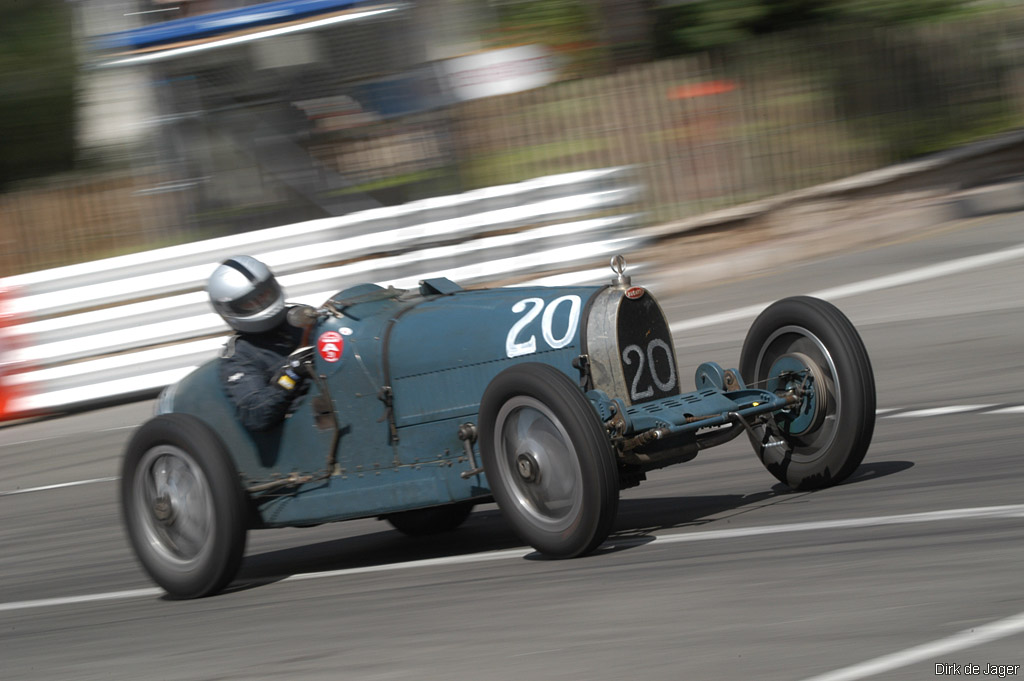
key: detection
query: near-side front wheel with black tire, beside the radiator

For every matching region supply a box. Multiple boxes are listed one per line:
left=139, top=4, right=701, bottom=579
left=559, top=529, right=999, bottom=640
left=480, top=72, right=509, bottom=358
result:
left=479, top=363, right=618, bottom=558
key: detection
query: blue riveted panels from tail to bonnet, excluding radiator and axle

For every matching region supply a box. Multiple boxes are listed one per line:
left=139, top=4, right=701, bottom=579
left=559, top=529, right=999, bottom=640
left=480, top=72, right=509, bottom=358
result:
left=160, top=285, right=600, bottom=526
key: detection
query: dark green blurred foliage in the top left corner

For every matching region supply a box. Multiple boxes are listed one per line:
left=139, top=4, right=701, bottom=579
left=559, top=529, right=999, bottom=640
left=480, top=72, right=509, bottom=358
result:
left=0, top=0, right=75, bottom=188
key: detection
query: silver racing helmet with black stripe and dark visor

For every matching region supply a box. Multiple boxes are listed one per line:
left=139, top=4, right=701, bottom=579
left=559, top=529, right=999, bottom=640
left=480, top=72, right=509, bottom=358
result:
left=207, top=255, right=287, bottom=333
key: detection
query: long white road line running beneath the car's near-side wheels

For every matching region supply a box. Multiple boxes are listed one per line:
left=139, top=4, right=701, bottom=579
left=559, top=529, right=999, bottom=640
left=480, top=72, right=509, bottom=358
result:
left=0, top=504, right=1024, bottom=612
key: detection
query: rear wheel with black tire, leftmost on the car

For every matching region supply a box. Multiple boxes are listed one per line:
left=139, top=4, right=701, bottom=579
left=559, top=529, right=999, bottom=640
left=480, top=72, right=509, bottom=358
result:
left=121, top=414, right=248, bottom=598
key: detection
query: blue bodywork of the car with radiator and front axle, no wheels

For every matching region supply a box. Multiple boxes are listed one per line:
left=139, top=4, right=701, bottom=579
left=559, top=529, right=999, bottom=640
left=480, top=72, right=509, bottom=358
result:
left=160, top=280, right=777, bottom=526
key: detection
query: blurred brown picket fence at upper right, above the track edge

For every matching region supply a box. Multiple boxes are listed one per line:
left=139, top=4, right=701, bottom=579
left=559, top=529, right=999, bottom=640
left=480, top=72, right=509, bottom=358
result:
left=453, top=15, right=1024, bottom=220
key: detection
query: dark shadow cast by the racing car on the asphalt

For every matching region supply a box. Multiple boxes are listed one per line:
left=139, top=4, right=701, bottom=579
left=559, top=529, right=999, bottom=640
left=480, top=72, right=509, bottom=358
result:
left=227, top=461, right=913, bottom=591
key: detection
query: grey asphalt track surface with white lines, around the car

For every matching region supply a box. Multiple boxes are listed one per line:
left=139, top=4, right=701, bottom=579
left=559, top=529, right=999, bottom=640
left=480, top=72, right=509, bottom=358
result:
left=0, top=209, right=1024, bottom=681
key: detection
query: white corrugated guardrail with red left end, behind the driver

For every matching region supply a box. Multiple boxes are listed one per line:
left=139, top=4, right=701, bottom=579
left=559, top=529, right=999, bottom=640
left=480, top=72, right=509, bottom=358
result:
left=0, top=168, right=644, bottom=421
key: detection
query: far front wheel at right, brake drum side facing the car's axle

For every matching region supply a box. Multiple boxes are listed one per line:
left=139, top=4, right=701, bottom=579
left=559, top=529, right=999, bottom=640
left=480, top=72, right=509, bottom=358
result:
left=739, top=296, right=876, bottom=490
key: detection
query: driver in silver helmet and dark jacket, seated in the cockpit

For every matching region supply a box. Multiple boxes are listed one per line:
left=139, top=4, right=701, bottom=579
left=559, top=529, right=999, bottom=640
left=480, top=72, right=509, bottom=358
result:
left=207, top=255, right=312, bottom=430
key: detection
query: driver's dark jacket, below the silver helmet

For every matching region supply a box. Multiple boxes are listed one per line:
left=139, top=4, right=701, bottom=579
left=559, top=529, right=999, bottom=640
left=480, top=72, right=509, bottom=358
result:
left=219, top=323, right=302, bottom=430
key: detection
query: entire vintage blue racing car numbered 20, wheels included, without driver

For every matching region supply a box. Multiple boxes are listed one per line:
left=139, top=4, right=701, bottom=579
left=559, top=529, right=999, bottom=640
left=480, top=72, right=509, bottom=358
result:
left=121, top=257, right=874, bottom=598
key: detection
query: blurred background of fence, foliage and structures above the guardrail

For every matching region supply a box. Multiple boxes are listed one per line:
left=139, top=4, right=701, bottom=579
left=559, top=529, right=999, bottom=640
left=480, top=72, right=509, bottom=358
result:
left=0, top=0, right=1024, bottom=276
